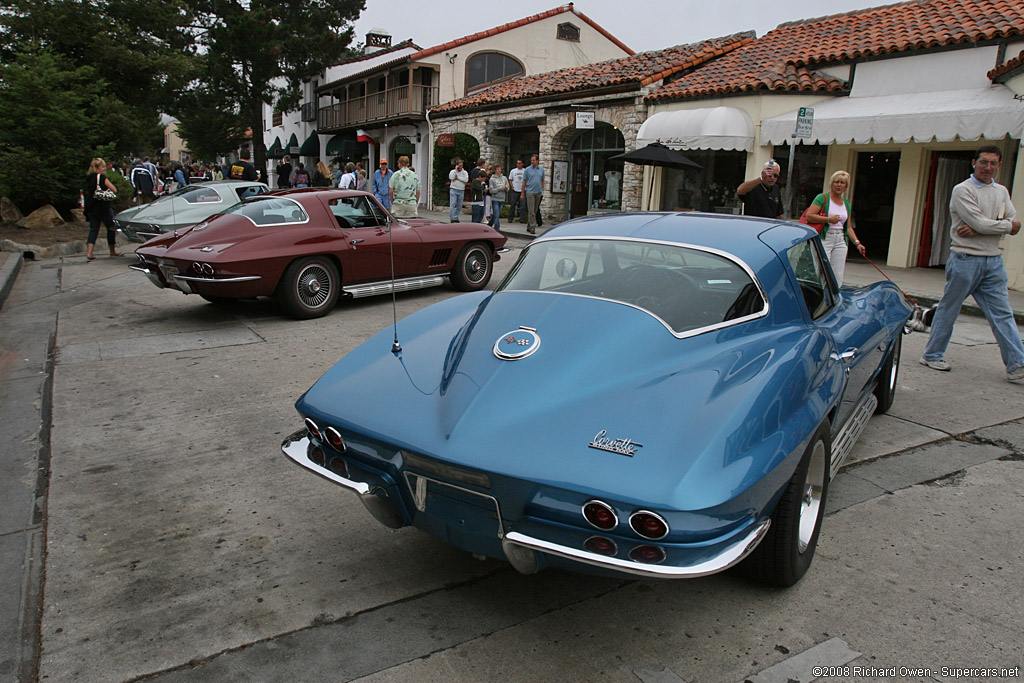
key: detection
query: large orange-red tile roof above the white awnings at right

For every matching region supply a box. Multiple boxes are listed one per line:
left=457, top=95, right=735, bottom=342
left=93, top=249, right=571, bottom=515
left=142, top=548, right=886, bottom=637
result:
left=647, top=0, right=1024, bottom=101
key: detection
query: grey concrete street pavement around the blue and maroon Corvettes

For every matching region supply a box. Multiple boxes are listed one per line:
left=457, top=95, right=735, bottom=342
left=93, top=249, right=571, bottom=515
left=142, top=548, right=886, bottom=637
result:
left=0, top=241, right=1024, bottom=683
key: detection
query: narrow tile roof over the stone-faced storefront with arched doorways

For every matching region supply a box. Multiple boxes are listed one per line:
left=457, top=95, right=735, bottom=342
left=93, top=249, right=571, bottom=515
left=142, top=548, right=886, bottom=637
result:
left=431, top=32, right=754, bottom=114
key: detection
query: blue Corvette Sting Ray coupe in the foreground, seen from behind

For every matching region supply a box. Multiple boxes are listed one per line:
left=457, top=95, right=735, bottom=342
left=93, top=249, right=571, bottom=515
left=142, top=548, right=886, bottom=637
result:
left=282, top=213, right=911, bottom=586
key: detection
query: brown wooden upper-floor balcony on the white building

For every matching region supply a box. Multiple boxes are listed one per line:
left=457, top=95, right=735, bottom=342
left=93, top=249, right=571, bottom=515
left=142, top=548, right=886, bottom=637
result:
left=316, top=85, right=438, bottom=133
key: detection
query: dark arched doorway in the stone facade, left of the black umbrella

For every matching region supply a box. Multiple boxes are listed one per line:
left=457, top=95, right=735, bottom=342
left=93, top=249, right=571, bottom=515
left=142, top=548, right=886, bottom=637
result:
left=566, top=122, right=626, bottom=218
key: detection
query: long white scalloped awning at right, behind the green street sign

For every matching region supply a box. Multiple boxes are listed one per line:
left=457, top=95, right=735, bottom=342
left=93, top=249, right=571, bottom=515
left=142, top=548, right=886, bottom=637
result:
left=761, top=85, right=1024, bottom=144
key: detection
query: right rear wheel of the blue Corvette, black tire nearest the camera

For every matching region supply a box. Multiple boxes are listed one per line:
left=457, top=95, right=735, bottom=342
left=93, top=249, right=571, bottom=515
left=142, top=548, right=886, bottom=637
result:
left=743, top=422, right=830, bottom=588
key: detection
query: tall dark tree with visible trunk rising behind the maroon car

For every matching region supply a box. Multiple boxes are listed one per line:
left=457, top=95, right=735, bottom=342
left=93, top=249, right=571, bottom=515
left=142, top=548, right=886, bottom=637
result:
left=193, top=0, right=365, bottom=168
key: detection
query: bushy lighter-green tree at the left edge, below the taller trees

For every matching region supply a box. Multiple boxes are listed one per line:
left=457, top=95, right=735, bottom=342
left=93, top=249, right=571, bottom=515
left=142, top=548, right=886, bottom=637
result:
left=0, top=50, right=112, bottom=213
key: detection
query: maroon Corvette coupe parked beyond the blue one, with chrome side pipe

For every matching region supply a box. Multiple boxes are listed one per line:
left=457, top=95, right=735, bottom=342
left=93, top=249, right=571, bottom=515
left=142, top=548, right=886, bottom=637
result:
left=131, top=189, right=506, bottom=318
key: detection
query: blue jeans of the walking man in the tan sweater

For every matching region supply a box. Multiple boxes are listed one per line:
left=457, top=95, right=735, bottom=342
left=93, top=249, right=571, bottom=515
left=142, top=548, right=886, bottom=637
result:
left=924, top=252, right=1024, bottom=372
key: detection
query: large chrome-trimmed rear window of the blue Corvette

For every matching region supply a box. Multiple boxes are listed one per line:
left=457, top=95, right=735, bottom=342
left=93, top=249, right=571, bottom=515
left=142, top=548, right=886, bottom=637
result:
left=498, top=239, right=767, bottom=336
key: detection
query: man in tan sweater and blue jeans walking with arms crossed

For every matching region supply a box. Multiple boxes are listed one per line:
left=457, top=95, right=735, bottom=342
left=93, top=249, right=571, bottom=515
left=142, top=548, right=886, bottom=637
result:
left=921, top=144, right=1024, bottom=382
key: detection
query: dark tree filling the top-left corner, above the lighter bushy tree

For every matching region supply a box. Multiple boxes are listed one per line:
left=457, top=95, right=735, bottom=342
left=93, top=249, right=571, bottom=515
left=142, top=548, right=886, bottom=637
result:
left=0, top=0, right=197, bottom=155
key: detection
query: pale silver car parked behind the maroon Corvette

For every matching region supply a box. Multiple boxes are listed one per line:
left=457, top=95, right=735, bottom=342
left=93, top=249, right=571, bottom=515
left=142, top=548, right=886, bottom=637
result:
left=114, top=180, right=268, bottom=242
